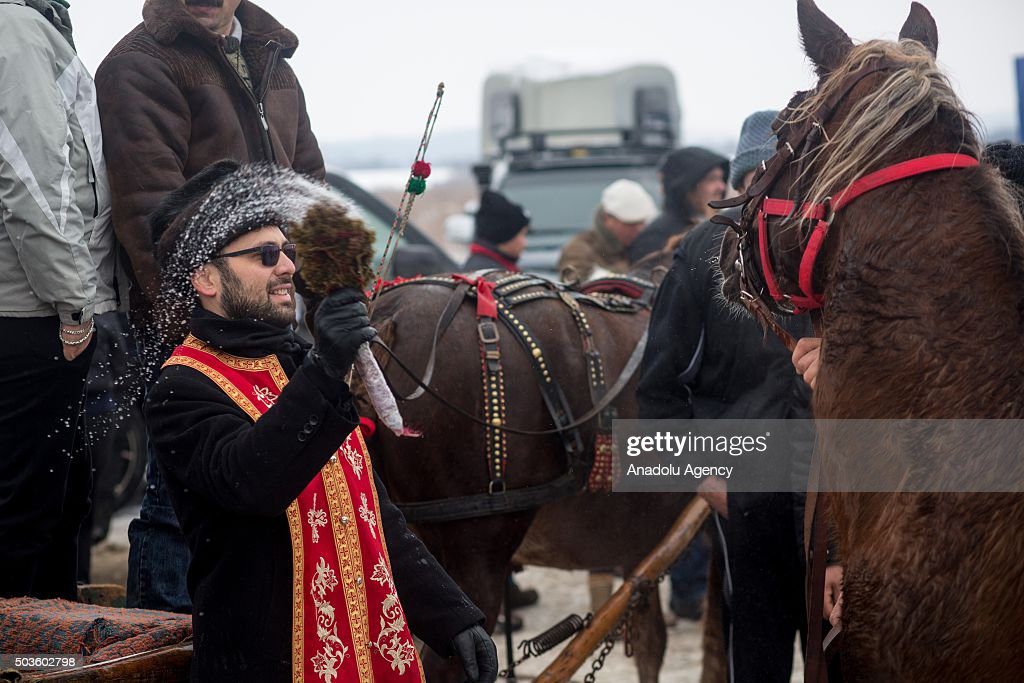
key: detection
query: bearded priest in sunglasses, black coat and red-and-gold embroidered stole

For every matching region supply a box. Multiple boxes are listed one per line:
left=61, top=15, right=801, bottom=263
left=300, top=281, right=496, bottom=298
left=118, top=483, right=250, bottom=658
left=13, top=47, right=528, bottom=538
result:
left=145, top=162, right=497, bottom=683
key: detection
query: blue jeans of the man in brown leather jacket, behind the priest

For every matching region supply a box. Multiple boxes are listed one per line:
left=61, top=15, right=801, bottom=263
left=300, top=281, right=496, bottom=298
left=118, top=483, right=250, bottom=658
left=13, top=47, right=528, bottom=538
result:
left=126, top=447, right=191, bottom=613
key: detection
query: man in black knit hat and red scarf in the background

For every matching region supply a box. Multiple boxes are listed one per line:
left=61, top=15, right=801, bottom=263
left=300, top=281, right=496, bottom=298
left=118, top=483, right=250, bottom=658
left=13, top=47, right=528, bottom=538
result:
left=462, top=189, right=529, bottom=272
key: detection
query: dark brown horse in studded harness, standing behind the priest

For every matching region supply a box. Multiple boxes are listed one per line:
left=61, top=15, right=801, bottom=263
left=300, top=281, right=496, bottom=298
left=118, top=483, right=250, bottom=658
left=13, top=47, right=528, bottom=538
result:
left=348, top=264, right=716, bottom=683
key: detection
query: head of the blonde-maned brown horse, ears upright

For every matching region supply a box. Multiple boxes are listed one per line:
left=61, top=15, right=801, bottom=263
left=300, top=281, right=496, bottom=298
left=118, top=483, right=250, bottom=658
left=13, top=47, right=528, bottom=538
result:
left=720, top=0, right=999, bottom=321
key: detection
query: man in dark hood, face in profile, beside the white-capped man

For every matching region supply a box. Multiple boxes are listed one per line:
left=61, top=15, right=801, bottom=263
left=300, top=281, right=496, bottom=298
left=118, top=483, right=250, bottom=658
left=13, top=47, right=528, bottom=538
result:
left=630, top=147, right=729, bottom=263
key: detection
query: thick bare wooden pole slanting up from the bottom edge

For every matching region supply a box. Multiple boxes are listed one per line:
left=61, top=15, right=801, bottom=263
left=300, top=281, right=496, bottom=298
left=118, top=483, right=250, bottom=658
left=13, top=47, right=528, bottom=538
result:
left=536, top=497, right=710, bottom=683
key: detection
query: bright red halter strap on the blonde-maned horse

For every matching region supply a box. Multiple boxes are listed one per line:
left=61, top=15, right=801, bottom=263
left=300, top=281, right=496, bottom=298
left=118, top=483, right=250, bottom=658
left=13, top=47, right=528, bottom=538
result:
left=758, top=154, right=978, bottom=313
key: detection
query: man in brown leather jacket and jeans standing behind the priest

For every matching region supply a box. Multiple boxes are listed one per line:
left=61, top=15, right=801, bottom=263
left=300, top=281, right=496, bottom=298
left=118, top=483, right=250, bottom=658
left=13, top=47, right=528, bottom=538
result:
left=96, top=0, right=325, bottom=611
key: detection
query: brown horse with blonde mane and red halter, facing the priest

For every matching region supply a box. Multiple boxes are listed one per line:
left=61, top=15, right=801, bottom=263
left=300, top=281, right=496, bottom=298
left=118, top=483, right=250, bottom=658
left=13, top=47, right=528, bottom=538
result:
left=721, top=0, right=1024, bottom=681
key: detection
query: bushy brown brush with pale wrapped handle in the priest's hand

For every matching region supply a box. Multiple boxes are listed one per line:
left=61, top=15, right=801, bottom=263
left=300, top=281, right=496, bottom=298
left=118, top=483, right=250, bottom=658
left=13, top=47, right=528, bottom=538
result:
left=289, top=200, right=416, bottom=436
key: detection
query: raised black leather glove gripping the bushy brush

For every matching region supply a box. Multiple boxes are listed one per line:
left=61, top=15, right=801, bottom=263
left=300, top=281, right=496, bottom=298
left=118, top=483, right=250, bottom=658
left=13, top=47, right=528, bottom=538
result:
left=312, top=289, right=377, bottom=380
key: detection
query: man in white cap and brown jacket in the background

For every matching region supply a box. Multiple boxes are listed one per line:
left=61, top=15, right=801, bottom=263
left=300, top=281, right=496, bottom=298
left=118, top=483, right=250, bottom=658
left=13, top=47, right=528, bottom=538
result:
left=558, top=178, right=657, bottom=281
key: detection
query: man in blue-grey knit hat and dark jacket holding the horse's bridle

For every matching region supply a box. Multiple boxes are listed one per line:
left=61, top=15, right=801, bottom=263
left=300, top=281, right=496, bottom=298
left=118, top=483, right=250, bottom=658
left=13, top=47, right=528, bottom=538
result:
left=637, top=112, right=810, bottom=682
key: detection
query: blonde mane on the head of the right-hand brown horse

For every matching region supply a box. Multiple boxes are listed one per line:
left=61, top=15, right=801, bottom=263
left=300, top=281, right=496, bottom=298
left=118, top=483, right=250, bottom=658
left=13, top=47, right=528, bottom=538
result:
left=786, top=40, right=981, bottom=204
